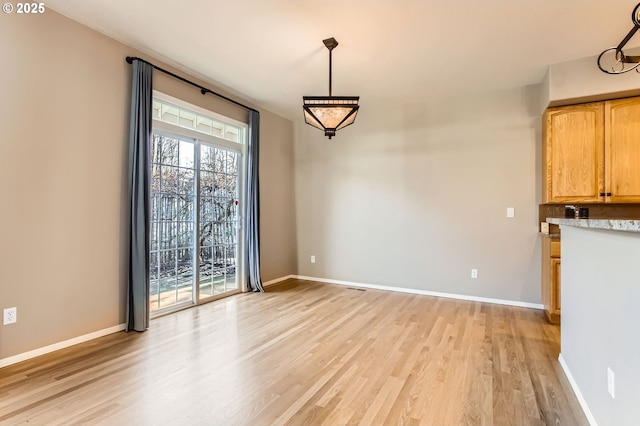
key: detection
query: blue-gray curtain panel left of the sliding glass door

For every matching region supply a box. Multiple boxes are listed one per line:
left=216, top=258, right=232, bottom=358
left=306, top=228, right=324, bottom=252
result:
left=127, top=60, right=153, bottom=331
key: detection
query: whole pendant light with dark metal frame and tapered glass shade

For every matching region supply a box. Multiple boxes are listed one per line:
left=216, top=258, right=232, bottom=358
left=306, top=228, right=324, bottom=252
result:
left=302, top=37, right=360, bottom=139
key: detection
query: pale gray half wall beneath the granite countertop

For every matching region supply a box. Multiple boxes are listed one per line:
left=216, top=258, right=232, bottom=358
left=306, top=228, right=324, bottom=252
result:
left=561, top=226, right=640, bottom=426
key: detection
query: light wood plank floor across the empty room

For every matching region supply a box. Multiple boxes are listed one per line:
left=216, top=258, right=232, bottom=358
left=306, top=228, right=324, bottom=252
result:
left=0, top=280, right=588, bottom=426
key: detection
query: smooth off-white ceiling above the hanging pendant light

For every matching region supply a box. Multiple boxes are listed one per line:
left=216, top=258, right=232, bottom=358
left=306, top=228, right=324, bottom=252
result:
left=47, top=0, right=640, bottom=120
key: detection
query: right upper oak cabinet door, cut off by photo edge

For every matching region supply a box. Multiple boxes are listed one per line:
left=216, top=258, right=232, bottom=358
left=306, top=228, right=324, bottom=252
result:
left=605, top=98, right=640, bottom=203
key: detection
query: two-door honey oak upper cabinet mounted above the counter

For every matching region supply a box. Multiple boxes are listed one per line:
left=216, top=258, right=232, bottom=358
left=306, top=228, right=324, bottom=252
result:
left=543, top=98, right=640, bottom=203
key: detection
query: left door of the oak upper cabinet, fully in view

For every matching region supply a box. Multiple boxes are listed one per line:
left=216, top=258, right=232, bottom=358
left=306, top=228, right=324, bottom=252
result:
left=543, top=102, right=604, bottom=203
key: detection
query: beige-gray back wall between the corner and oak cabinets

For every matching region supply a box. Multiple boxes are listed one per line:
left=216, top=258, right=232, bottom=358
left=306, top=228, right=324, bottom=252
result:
left=295, top=87, right=541, bottom=303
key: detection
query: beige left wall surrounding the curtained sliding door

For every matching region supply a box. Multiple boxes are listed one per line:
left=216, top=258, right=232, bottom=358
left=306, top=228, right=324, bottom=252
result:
left=0, top=10, right=296, bottom=360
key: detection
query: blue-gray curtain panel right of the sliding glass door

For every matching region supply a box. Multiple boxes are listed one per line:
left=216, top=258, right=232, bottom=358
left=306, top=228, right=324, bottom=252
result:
left=246, top=110, right=264, bottom=292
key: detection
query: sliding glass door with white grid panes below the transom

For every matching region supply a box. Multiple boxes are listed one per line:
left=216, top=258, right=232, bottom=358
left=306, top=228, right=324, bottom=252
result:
left=149, top=130, right=243, bottom=315
